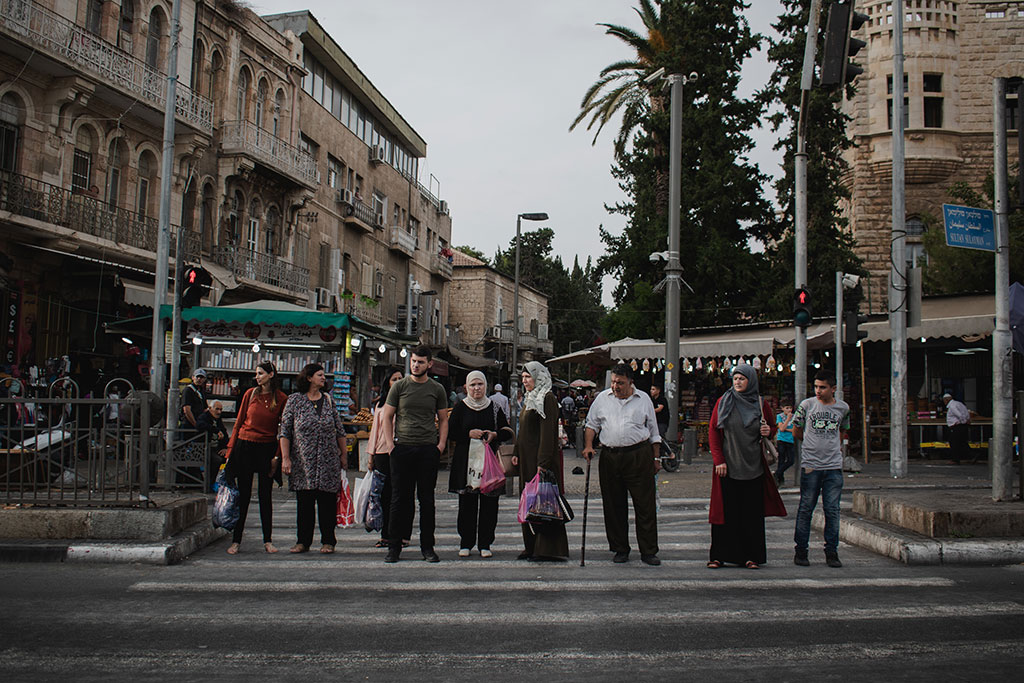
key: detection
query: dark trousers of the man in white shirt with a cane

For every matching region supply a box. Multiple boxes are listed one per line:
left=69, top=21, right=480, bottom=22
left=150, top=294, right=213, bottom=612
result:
left=598, top=442, right=657, bottom=555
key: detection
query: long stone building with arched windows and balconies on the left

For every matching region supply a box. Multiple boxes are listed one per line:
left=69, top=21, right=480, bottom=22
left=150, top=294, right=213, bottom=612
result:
left=0, top=0, right=452, bottom=387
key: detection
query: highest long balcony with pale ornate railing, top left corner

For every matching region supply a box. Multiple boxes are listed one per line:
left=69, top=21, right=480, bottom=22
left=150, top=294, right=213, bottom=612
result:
left=0, top=0, right=213, bottom=133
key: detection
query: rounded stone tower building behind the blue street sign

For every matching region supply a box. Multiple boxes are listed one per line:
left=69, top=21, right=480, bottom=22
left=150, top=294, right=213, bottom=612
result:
left=846, top=0, right=1024, bottom=312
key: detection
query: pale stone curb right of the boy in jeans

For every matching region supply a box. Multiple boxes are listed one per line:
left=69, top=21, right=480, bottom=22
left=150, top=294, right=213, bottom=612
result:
left=811, top=510, right=1024, bottom=566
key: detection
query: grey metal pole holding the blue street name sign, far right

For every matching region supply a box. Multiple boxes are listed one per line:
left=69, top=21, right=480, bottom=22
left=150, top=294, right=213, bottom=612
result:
left=988, top=78, right=1019, bottom=501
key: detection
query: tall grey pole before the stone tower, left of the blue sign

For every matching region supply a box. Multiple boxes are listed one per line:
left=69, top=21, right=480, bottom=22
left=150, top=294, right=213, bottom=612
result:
left=889, top=0, right=909, bottom=479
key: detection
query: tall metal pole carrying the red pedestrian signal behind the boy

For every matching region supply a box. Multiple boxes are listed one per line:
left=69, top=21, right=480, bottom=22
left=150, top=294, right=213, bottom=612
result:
left=793, top=0, right=821, bottom=471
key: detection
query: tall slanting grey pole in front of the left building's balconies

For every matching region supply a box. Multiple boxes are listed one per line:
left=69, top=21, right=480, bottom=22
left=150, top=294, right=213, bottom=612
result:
left=150, top=0, right=181, bottom=396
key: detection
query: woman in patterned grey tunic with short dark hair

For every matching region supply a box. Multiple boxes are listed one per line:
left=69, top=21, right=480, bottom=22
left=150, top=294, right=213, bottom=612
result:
left=279, top=362, right=347, bottom=554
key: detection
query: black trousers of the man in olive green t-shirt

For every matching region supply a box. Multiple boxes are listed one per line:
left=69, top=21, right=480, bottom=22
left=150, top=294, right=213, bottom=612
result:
left=387, top=443, right=440, bottom=550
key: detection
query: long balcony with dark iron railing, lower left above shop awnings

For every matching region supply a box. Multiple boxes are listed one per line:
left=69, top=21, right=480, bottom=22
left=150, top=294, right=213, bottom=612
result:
left=0, top=171, right=200, bottom=259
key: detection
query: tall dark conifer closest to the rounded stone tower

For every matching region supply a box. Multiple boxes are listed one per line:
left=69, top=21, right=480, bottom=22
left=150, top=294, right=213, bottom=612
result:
left=758, top=0, right=864, bottom=319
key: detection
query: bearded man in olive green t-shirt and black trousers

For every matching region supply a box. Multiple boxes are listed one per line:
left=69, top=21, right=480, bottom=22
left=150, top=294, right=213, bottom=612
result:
left=381, top=346, right=447, bottom=562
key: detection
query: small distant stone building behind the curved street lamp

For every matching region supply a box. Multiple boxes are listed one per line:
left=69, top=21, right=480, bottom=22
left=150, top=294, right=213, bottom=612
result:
left=450, top=251, right=554, bottom=378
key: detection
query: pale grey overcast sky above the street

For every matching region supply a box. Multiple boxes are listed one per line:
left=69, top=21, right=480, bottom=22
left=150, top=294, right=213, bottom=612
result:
left=253, top=0, right=780, bottom=303
